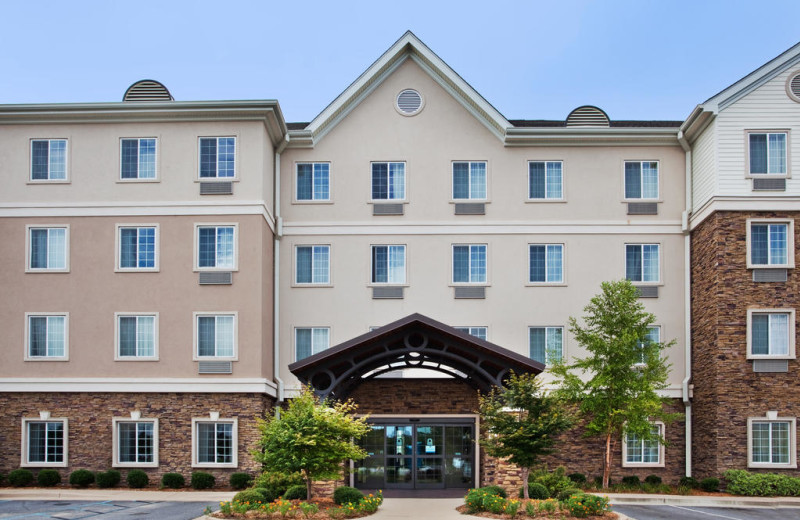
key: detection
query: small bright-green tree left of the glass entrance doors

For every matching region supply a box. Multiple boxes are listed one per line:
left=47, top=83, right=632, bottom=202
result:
left=253, top=388, right=369, bottom=499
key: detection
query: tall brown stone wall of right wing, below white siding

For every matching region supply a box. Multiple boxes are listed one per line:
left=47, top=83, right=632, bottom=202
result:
left=692, top=212, right=800, bottom=477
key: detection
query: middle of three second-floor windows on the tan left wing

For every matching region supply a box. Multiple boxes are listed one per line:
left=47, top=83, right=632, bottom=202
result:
left=114, top=312, right=158, bottom=361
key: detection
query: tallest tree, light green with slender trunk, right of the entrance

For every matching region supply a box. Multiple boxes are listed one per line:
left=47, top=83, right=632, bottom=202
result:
left=551, top=280, right=680, bottom=487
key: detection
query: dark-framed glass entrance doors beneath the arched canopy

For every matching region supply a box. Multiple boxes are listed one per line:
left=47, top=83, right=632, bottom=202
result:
left=354, top=418, right=476, bottom=489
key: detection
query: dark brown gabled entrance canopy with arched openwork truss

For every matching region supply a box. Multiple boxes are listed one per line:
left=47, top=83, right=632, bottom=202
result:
left=289, top=314, right=544, bottom=399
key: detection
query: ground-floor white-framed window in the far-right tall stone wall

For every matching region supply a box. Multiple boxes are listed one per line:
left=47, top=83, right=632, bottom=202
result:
left=747, top=411, right=797, bottom=469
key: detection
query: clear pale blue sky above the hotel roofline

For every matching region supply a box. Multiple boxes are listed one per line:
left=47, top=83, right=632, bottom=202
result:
left=0, top=0, right=800, bottom=121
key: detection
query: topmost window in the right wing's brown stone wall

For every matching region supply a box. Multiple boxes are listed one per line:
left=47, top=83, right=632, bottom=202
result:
left=747, top=219, right=795, bottom=269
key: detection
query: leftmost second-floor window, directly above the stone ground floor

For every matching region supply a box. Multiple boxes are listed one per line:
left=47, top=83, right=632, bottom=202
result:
left=25, top=312, right=69, bottom=361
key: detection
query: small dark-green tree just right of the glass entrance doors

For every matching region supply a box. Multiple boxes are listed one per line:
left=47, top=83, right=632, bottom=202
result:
left=479, top=372, right=572, bottom=499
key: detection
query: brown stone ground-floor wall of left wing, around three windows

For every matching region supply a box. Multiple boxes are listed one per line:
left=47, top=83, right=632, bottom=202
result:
left=0, top=393, right=273, bottom=486
